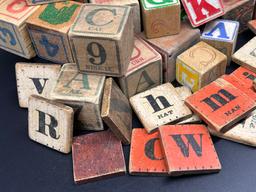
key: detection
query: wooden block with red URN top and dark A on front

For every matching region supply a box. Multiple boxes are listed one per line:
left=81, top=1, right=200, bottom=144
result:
left=118, top=37, right=163, bottom=98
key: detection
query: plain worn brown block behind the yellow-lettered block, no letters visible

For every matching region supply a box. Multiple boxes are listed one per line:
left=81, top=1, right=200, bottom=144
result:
left=141, top=22, right=200, bottom=82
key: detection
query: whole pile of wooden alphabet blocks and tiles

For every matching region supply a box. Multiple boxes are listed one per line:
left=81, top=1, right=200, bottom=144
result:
left=0, top=0, right=256, bottom=183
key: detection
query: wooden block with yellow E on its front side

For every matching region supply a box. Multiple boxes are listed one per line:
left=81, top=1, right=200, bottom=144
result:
left=176, top=42, right=227, bottom=92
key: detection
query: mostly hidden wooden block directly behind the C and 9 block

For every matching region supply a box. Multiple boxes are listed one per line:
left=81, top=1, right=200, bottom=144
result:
left=90, top=0, right=141, bottom=33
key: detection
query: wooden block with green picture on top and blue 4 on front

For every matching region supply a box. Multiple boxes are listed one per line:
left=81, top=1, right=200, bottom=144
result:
left=27, top=1, right=81, bottom=63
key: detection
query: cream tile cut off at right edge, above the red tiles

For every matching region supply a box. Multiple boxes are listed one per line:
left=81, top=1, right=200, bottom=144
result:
left=232, top=37, right=256, bottom=72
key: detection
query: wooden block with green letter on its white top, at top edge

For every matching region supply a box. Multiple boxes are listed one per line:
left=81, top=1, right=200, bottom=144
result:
left=140, top=0, right=180, bottom=38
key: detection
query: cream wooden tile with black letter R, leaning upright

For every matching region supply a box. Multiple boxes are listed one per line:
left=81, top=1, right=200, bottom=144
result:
left=28, top=95, right=74, bottom=153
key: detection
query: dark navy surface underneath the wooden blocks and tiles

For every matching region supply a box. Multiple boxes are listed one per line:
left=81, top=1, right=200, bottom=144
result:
left=0, top=31, right=256, bottom=192
